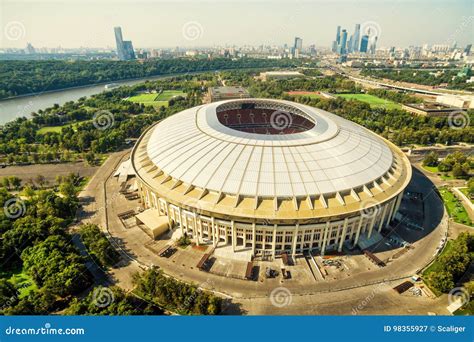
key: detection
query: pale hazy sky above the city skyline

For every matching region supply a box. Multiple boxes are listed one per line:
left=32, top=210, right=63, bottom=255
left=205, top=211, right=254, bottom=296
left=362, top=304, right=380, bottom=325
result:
left=0, top=0, right=474, bottom=48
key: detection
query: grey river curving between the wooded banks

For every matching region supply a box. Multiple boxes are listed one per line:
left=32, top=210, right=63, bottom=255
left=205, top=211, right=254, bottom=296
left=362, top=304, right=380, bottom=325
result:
left=0, top=75, right=183, bottom=125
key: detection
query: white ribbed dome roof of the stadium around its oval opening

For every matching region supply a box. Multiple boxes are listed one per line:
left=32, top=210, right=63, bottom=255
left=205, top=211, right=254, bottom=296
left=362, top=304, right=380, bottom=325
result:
left=146, top=99, right=394, bottom=198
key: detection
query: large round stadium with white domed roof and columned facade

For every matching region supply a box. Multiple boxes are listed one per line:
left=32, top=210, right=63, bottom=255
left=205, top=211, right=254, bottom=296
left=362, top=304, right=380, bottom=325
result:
left=131, top=99, right=411, bottom=257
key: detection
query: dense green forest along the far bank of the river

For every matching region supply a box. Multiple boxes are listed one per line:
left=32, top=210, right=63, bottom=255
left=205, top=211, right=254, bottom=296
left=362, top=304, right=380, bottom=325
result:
left=0, top=58, right=301, bottom=99
